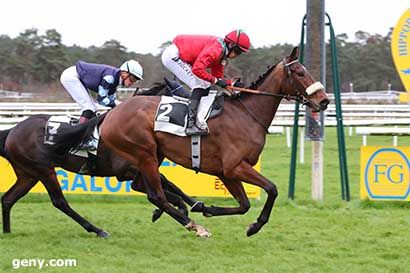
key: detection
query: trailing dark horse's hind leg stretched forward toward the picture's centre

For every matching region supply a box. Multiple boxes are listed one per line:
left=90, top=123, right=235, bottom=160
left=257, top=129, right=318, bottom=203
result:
left=41, top=170, right=109, bottom=238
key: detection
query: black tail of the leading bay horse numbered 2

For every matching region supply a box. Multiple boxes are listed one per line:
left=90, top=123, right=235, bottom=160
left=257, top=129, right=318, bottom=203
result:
left=48, top=113, right=106, bottom=157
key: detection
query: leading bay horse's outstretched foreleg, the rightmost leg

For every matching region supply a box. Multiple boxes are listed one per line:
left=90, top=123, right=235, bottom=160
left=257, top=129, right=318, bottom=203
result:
left=227, top=161, right=278, bottom=236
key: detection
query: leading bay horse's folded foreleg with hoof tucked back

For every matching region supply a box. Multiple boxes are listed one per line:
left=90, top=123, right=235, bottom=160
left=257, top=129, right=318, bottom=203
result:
left=202, top=177, right=250, bottom=217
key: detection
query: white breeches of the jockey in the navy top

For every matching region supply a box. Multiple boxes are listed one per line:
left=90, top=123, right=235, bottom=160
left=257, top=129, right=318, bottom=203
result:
left=60, top=66, right=97, bottom=112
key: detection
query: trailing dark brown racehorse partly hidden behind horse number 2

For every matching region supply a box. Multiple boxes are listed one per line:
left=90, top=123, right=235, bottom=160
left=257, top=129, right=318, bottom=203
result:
left=0, top=85, right=199, bottom=237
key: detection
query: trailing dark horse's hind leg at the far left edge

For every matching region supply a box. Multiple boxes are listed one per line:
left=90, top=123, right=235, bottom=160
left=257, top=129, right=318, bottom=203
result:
left=1, top=174, right=38, bottom=233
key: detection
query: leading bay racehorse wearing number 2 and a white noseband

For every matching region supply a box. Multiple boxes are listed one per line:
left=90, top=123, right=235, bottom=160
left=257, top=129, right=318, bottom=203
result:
left=50, top=48, right=329, bottom=237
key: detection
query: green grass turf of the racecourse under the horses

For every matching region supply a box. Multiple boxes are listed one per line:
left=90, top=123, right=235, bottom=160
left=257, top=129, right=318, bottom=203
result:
left=0, top=126, right=410, bottom=273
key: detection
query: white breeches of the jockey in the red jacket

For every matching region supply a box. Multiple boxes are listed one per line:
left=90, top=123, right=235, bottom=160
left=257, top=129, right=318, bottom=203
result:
left=161, top=44, right=211, bottom=89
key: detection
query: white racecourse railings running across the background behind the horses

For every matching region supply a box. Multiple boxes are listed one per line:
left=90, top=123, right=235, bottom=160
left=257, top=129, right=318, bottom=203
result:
left=0, top=102, right=410, bottom=130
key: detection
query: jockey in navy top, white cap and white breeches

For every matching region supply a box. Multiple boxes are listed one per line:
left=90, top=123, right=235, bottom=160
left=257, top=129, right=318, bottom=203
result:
left=60, top=60, right=143, bottom=123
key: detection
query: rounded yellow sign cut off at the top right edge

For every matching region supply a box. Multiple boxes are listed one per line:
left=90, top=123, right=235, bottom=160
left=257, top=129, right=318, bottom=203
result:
left=391, top=8, right=410, bottom=92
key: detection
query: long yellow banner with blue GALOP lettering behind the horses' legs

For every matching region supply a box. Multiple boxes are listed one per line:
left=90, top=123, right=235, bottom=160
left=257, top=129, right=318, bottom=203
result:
left=0, top=157, right=260, bottom=198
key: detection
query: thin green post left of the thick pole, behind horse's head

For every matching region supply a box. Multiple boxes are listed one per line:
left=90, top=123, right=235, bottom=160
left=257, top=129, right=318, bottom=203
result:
left=288, top=15, right=306, bottom=200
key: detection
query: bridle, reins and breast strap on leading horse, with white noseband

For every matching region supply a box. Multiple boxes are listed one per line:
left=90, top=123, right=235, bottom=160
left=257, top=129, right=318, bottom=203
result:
left=238, top=58, right=323, bottom=133
